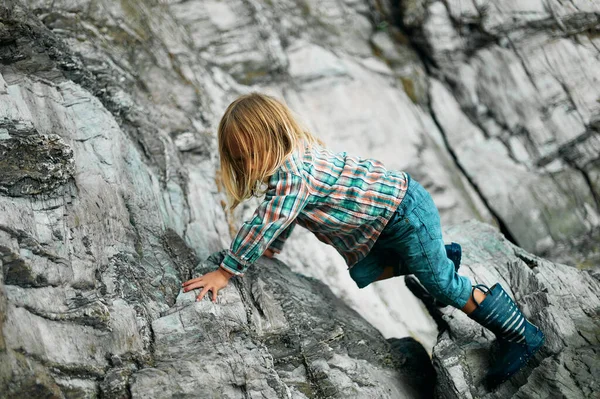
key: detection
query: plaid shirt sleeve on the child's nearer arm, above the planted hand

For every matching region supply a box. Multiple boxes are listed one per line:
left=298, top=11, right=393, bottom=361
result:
left=221, top=170, right=308, bottom=275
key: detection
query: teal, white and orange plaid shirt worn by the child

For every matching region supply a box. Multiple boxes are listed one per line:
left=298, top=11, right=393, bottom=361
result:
left=221, top=145, right=407, bottom=275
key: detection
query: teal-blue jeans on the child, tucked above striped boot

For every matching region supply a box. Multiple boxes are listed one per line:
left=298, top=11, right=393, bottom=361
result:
left=350, top=177, right=471, bottom=309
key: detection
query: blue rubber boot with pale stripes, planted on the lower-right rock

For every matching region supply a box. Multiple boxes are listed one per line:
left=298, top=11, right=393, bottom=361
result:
left=469, top=284, right=545, bottom=388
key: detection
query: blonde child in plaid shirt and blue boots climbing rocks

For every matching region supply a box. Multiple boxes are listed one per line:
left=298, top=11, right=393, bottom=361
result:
left=183, top=93, right=544, bottom=385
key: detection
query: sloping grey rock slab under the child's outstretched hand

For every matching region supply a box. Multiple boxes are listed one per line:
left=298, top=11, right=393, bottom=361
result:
left=130, top=255, right=435, bottom=398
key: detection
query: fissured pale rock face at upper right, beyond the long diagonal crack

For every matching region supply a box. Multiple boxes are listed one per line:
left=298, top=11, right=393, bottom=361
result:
left=392, top=0, right=600, bottom=267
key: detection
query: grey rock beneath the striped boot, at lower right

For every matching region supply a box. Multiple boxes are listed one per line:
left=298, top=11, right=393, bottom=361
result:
left=418, top=222, right=600, bottom=399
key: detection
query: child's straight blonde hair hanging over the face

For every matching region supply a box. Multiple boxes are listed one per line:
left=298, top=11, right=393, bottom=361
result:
left=218, top=93, right=323, bottom=210
